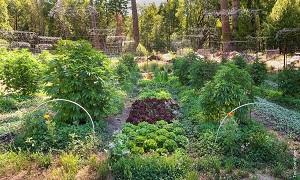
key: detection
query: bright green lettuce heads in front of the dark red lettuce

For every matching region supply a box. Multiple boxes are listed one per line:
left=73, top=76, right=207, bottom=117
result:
left=112, top=121, right=188, bottom=158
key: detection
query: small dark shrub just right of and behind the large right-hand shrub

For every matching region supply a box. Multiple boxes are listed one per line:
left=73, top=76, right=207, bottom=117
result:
left=250, top=59, right=268, bottom=85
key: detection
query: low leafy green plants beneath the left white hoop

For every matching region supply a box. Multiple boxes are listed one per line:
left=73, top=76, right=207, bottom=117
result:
left=14, top=109, right=104, bottom=154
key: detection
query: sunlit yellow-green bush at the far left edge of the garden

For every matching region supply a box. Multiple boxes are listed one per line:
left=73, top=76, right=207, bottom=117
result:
left=0, top=50, right=41, bottom=95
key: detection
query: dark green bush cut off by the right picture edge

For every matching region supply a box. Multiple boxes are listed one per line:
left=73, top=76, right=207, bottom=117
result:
left=278, top=68, right=300, bottom=96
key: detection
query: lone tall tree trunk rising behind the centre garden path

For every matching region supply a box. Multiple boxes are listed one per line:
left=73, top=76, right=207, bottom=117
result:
left=131, top=0, right=140, bottom=50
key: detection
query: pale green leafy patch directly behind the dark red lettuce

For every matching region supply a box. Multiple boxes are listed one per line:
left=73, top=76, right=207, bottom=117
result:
left=139, top=89, right=172, bottom=100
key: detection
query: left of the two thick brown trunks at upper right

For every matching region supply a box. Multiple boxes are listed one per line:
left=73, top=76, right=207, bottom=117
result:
left=220, top=0, right=231, bottom=52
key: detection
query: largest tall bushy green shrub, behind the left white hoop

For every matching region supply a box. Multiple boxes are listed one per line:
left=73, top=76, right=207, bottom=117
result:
left=46, top=41, right=113, bottom=124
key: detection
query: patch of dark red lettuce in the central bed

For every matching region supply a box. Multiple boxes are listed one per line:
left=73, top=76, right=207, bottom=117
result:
left=127, top=99, right=179, bottom=124
